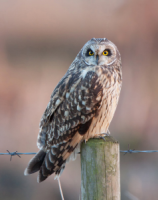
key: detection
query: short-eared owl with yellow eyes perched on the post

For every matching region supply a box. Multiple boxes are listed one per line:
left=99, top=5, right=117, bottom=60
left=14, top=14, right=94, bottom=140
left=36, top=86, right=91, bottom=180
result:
left=24, top=38, right=122, bottom=182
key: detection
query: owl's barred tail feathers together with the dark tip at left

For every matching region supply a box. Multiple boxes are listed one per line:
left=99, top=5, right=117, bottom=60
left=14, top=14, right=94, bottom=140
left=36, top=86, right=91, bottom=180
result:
left=24, top=132, right=83, bottom=183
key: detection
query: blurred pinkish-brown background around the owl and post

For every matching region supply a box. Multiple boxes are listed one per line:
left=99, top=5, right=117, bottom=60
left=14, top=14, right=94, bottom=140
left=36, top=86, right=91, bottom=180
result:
left=0, top=0, right=158, bottom=200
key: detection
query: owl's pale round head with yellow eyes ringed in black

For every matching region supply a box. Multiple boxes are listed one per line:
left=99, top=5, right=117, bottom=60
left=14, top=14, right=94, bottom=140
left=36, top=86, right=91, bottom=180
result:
left=80, top=38, right=121, bottom=65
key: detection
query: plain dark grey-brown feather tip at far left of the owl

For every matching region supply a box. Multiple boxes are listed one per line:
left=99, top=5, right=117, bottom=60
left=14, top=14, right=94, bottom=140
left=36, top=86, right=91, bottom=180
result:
left=24, top=149, right=46, bottom=176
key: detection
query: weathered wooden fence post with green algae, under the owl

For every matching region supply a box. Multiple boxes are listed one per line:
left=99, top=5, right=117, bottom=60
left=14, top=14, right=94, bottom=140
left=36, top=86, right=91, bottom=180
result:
left=81, top=136, right=120, bottom=200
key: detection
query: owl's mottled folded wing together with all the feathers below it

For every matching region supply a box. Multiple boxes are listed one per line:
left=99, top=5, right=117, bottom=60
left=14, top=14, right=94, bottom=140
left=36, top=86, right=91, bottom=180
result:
left=25, top=71, right=103, bottom=182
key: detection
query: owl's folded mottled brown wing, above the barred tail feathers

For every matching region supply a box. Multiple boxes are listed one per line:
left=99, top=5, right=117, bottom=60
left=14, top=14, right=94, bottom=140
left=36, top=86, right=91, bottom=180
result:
left=38, top=71, right=103, bottom=149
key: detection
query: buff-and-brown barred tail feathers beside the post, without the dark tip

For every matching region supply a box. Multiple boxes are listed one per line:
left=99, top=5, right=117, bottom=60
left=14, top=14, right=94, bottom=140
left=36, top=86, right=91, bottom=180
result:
left=37, top=133, right=83, bottom=182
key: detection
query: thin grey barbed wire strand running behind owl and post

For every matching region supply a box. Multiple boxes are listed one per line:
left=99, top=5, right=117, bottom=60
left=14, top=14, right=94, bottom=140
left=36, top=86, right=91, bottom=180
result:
left=0, top=149, right=158, bottom=161
